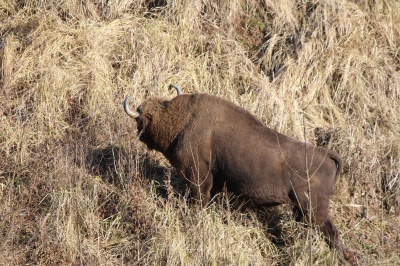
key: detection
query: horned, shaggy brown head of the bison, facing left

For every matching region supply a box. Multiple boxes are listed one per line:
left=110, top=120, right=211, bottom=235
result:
left=124, top=85, right=182, bottom=150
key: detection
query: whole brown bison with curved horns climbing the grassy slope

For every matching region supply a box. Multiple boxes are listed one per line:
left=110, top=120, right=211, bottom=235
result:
left=124, top=86, right=344, bottom=254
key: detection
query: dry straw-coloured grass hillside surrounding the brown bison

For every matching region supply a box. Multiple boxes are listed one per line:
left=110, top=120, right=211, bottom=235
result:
left=0, top=0, right=400, bottom=265
